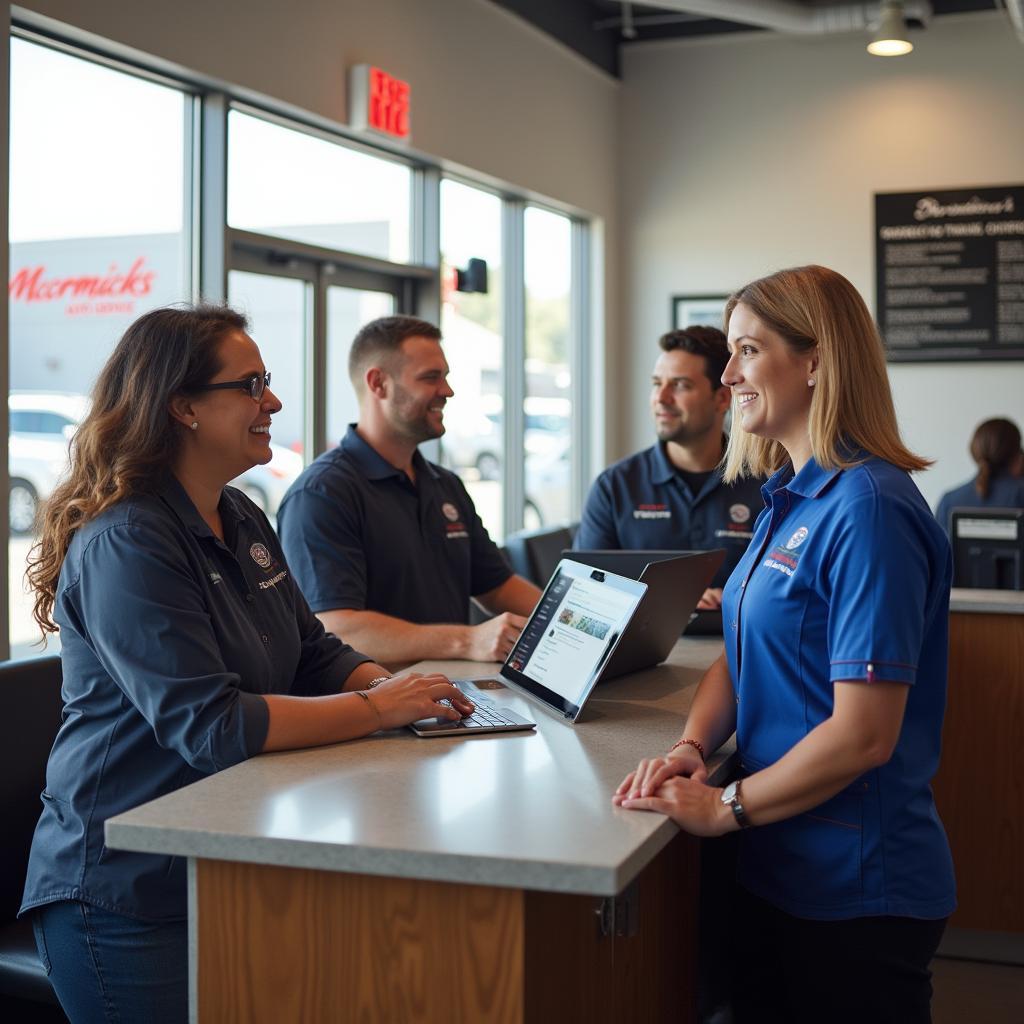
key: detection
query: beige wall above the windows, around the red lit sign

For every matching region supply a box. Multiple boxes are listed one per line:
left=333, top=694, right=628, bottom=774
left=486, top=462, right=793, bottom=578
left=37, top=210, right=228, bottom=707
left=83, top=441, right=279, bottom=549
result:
left=12, top=0, right=621, bottom=459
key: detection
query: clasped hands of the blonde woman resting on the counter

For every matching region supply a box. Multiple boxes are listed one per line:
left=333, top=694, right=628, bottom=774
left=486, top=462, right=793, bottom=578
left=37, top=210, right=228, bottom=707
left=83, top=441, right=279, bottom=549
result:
left=611, top=746, right=729, bottom=836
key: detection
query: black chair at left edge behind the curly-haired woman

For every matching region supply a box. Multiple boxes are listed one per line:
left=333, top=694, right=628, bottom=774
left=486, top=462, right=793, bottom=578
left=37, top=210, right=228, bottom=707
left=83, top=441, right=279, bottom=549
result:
left=0, top=657, right=62, bottom=1016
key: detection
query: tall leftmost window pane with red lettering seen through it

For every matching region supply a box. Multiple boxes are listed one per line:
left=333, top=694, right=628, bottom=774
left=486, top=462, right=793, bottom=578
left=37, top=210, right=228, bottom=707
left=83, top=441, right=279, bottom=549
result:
left=8, top=38, right=193, bottom=656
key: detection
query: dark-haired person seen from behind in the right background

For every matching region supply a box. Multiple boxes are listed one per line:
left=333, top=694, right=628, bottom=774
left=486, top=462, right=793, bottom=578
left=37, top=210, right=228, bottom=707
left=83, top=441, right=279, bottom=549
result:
left=935, top=419, right=1024, bottom=537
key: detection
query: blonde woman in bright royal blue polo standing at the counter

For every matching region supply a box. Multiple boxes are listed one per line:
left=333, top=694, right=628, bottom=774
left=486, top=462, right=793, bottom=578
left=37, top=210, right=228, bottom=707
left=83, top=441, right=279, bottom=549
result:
left=614, top=266, right=955, bottom=1024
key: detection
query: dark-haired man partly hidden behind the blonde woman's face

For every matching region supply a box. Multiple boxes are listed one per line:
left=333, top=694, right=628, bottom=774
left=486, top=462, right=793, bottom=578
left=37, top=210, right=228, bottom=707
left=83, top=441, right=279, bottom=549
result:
left=573, top=327, right=764, bottom=609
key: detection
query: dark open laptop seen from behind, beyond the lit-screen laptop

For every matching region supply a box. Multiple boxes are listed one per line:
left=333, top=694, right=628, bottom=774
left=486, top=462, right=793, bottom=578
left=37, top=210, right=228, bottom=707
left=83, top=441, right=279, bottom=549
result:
left=563, top=548, right=725, bottom=681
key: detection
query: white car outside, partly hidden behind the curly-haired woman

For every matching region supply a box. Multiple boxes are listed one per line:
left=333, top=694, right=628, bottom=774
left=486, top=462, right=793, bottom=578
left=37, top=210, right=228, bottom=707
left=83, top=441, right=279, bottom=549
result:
left=7, top=391, right=302, bottom=537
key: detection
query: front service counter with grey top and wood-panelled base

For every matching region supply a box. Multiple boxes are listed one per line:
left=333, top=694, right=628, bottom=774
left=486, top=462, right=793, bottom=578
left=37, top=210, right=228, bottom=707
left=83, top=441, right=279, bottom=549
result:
left=106, top=639, right=728, bottom=1024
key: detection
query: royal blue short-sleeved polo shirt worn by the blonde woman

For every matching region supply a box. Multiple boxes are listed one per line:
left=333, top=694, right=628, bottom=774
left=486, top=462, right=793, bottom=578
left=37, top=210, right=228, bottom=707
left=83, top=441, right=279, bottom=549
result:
left=723, top=456, right=955, bottom=920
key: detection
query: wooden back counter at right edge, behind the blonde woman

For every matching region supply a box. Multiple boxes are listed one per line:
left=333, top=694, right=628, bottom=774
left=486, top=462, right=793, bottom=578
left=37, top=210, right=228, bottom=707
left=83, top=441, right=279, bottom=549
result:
left=933, top=590, right=1024, bottom=942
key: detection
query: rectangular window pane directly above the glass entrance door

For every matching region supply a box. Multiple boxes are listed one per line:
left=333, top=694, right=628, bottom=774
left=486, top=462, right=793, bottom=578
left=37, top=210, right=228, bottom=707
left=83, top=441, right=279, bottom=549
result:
left=227, top=111, right=413, bottom=263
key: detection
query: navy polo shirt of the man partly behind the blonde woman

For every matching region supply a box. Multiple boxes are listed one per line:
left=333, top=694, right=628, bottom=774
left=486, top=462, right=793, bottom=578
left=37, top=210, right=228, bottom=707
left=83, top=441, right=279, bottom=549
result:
left=573, top=443, right=764, bottom=587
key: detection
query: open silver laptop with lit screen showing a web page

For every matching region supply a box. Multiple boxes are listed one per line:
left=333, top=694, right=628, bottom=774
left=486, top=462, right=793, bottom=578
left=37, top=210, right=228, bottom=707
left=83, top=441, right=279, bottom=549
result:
left=410, top=558, right=647, bottom=736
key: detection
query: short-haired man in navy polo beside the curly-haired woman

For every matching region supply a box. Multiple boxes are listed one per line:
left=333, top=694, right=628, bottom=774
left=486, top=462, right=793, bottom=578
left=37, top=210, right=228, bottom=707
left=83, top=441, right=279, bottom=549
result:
left=278, top=316, right=541, bottom=666
